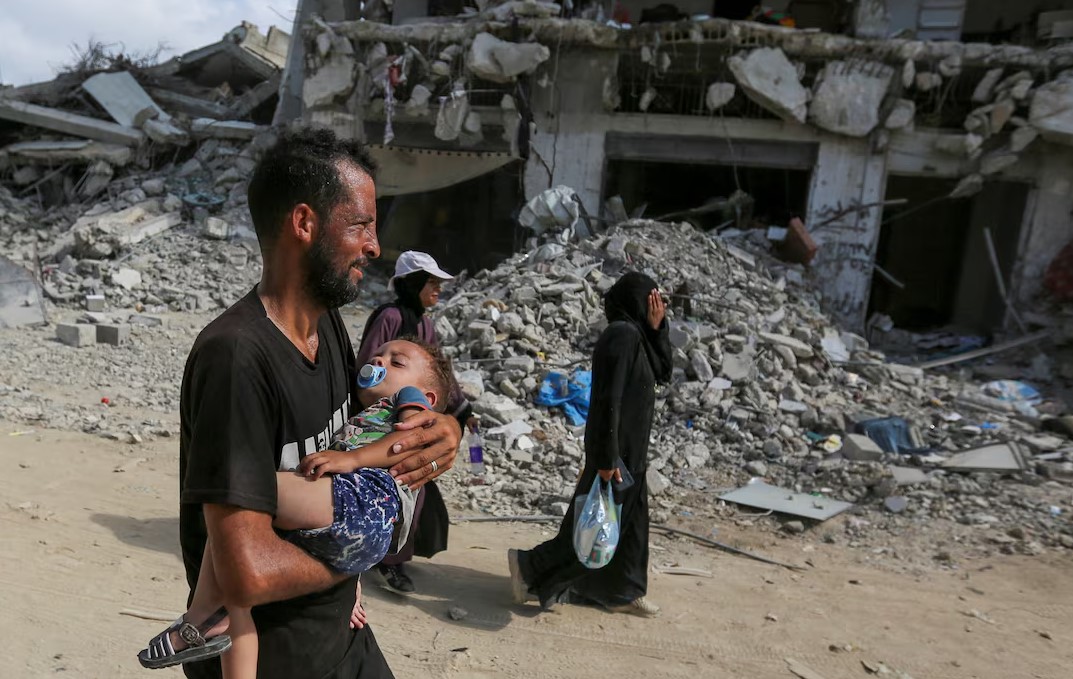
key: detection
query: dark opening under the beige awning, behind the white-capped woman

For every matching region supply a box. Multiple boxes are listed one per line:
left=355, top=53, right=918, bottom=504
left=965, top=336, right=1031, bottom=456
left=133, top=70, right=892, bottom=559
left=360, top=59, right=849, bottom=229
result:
left=377, top=161, right=525, bottom=274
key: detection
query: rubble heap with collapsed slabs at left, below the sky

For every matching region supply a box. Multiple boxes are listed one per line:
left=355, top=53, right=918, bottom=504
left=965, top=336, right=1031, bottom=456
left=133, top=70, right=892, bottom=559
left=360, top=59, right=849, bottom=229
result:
left=0, top=24, right=290, bottom=332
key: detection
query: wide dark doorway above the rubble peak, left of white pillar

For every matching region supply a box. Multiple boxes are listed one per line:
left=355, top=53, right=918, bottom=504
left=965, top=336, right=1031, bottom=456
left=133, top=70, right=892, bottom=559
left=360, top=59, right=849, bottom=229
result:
left=603, top=133, right=817, bottom=230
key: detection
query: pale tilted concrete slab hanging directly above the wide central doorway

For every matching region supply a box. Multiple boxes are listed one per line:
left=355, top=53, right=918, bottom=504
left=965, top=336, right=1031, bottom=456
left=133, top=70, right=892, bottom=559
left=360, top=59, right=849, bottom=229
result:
left=726, top=47, right=808, bottom=123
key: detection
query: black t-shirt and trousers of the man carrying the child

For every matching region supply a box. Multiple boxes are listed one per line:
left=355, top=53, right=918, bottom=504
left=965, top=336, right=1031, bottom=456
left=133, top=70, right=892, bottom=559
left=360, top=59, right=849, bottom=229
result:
left=179, top=289, right=391, bottom=679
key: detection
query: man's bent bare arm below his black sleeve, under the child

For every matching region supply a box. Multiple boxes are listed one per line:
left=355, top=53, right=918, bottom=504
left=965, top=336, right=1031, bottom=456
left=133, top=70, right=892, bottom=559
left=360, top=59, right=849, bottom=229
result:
left=204, top=504, right=348, bottom=608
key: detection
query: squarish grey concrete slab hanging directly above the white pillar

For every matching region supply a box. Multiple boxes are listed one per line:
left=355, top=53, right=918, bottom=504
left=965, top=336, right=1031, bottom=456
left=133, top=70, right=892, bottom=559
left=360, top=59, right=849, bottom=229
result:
left=808, top=61, right=894, bottom=137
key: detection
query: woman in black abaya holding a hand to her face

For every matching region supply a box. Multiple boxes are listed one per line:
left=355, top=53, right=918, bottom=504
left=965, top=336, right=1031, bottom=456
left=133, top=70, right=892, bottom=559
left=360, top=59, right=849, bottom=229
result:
left=508, top=272, right=672, bottom=617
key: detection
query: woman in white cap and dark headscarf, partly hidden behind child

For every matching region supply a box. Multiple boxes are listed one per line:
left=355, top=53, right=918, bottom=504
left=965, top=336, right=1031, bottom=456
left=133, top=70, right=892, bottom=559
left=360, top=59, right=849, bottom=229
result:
left=357, top=250, right=473, bottom=594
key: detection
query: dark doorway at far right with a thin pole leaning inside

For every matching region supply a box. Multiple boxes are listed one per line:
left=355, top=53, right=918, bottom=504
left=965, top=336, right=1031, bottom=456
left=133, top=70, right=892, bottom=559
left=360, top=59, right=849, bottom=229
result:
left=869, top=175, right=1030, bottom=334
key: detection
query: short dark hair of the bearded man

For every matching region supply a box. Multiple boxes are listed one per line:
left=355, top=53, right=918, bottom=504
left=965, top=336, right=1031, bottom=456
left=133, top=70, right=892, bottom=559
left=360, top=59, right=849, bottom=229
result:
left=247, top=126, right=377, bottom=249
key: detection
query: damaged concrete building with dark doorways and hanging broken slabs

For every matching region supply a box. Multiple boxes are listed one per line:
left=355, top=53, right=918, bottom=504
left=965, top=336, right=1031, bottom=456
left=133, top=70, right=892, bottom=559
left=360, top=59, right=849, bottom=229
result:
left=278, top=0, right=1073, bottom=333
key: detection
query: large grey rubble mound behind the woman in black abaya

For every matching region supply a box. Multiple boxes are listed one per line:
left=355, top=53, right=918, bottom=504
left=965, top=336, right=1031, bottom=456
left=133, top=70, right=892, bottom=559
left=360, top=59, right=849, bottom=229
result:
left=436, top=221, right=1073, bottom=550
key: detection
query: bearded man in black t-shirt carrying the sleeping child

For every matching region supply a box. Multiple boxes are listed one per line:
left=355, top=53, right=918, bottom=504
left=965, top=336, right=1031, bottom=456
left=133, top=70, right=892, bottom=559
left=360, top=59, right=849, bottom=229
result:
left=169, top=129, right=461, bottom=679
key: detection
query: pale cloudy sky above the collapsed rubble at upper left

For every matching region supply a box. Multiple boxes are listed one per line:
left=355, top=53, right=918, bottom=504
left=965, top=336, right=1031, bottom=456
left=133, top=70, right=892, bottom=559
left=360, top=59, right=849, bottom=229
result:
left=0, top=0, right=298, bottom=85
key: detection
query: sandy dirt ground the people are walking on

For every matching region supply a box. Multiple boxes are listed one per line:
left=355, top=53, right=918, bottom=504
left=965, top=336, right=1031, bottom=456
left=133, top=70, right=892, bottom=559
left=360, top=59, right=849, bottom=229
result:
left=0, top=422, right=1073, bottom=679
